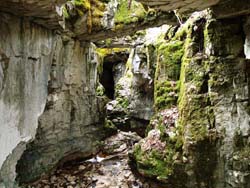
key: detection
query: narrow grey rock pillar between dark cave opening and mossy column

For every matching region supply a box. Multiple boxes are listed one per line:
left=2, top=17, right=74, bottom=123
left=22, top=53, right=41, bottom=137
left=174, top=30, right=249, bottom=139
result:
left=129, top=45, right=155, bottom=120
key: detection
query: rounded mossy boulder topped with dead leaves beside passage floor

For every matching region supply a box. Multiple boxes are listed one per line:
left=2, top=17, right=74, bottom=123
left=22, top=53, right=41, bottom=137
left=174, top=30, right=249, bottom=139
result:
left=133, top=107, right=183, bottom=182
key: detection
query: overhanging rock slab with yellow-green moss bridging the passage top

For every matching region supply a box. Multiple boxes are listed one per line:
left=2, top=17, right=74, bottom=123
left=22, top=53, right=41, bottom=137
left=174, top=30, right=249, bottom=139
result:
left=0, top=0, right=177, bottom=41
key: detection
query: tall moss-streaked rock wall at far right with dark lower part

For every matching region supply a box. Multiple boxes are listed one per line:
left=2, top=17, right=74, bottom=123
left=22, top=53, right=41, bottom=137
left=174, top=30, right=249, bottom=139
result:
left=179, top=13, right=249, bottom=188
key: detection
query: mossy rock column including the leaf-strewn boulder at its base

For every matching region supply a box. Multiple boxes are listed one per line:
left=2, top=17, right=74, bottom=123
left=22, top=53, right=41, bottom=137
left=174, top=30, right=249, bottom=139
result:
left=133, top=22, right=186, bottom=187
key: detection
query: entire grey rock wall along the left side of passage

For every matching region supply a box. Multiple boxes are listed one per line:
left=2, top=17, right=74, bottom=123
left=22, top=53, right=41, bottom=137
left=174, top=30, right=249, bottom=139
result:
left=0, top=14, right=104, bottom=188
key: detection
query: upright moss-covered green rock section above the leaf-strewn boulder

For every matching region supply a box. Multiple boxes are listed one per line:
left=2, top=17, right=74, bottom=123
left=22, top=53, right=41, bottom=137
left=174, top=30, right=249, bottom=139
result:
left=154, top=40, right=184, bottom=110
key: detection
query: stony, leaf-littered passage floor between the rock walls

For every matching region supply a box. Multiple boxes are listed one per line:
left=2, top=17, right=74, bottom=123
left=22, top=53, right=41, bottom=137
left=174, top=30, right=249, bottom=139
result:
left=27, top=131, right=167, bottom=188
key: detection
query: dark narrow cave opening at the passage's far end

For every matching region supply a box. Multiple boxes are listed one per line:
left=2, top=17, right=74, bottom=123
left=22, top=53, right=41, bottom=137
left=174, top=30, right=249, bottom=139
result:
left=99, top=51, right=129, bottom=99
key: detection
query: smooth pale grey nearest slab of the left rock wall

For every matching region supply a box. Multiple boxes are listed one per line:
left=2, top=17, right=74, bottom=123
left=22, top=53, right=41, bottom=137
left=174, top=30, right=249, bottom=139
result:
left=0, top=14, right=54, bottom=187
